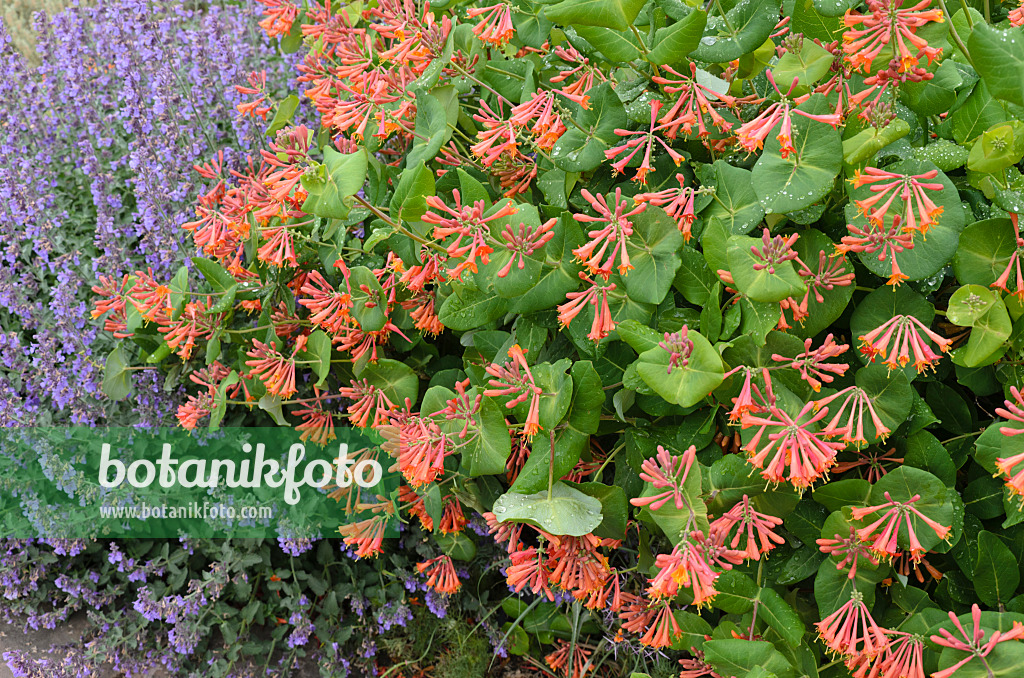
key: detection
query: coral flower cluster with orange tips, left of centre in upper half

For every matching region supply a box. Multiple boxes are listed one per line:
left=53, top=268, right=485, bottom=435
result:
left=423, top=189, right=519, bottom=280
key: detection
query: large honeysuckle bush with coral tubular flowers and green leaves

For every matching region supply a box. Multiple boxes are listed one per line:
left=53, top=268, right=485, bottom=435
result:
left=95, top=0, right=1024, bottom=678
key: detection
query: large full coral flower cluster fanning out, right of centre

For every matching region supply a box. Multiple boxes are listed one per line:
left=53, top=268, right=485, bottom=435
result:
left=743, top=402, right=844, bottom=489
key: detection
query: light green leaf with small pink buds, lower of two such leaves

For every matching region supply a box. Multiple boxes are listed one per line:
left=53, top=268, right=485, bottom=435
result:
left=637, top=330, right=725, bottom=408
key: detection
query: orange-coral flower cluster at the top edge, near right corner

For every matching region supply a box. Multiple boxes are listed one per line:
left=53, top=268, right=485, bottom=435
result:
left=843, top=0, right=944, bottom=73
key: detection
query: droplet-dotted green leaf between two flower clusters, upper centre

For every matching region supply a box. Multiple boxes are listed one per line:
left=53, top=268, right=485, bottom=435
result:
left=548, top=82, right=622, bottom=172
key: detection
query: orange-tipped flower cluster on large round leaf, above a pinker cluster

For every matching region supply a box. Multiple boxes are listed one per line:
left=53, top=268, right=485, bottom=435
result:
left=850, top=167, right=943, bottom=236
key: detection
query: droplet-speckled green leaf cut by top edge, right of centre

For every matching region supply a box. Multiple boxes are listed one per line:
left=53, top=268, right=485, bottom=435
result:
left=692, top=0, right=779, bottom=63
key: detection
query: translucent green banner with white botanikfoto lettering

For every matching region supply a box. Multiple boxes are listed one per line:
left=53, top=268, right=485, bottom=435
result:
left=0, top=427, right=398, bottom=539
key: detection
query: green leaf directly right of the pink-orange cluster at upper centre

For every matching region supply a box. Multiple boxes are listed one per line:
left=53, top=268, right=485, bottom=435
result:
left=623, top=207, right=683, bottom=304
